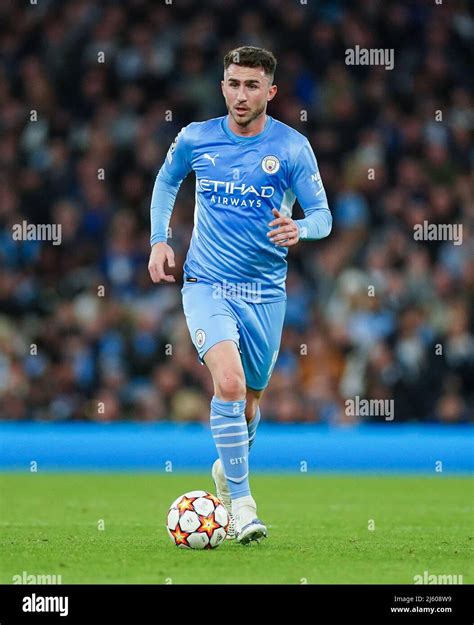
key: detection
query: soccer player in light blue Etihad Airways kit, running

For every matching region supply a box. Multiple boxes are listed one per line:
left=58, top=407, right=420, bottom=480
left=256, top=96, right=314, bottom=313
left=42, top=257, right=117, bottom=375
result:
left=148, top=46, right=332, bottom=544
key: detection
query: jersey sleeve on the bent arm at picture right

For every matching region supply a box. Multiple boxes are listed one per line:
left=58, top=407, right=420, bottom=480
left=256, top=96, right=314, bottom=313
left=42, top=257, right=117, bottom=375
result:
left=290, top=140, right=332, bottom=240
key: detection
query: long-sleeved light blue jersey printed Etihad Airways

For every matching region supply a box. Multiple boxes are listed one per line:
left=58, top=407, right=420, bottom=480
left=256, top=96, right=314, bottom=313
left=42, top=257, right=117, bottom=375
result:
left=150, top=116, right=332, bottom=302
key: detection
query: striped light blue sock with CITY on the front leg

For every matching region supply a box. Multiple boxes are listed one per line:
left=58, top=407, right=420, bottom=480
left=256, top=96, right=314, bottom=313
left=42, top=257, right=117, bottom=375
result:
left=211, top=395, right=250, bottom=500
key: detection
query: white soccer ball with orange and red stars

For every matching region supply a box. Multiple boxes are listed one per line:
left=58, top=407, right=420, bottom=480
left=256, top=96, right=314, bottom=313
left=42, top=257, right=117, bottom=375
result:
left=166, top=490, right=230, bottom=549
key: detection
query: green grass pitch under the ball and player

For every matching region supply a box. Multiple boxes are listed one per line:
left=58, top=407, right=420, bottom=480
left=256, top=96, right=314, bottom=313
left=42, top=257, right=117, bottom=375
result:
left=0, top=473, right=474, bottom=584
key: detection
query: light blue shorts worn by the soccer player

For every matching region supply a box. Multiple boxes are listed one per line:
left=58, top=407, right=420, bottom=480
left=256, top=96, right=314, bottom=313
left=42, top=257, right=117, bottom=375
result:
left=181, top=282, right=286, bottom=391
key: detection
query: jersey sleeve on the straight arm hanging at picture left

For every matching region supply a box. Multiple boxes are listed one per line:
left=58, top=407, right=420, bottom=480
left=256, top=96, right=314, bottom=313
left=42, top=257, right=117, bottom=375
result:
left=150, top=126, right=191, bottom=246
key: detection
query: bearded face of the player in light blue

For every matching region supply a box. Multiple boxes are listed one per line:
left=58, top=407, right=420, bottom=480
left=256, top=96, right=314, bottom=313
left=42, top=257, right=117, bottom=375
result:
left=221, top=64, right=277, bottom=126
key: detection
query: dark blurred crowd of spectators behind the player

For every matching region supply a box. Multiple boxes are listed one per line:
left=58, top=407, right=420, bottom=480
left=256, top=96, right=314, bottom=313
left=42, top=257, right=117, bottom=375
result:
left=0, top=0, right=474, bottom=424
